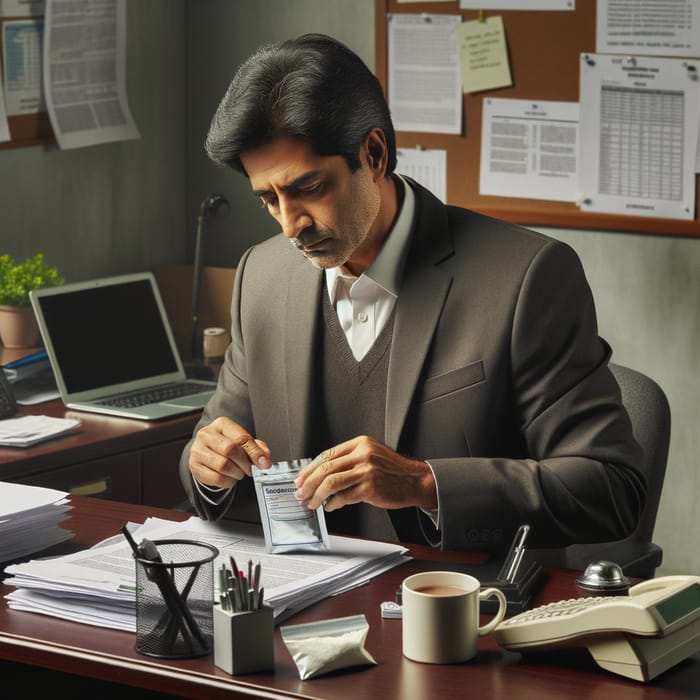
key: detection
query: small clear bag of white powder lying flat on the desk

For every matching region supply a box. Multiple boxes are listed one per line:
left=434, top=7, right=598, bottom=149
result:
left=280, top=615, right=377, bottom=680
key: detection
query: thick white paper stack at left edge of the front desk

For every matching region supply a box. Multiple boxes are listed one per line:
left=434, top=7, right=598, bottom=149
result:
left=0, top=482, right=73, bottom=562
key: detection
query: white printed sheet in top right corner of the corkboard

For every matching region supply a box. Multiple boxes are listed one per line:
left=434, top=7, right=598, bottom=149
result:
left=596, top=0, right=700, bottom=58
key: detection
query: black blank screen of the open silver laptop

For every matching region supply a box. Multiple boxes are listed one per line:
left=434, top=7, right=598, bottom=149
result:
left=35, top=273, right=180, bottom=394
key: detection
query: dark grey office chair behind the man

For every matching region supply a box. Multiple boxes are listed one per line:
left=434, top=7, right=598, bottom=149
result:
left=533, top=363, right=671, bottom=578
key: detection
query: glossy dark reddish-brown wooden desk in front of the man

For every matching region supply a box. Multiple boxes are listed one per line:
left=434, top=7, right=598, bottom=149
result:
left=0, top=497, right=700, bottom=700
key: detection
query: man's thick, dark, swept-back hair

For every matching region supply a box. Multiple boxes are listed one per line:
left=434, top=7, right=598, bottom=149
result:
left=205, top=34, right=396, bottom=175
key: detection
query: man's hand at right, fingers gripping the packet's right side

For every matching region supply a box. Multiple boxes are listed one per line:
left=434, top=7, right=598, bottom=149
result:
left=295, top=435, right=437, bottom=511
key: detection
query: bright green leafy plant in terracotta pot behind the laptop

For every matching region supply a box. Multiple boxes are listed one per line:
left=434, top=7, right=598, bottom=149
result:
left=0, top=253, right=65, bottom=348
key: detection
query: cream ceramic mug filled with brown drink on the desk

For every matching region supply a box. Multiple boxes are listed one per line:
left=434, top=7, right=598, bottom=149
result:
left=401, top=571, right=507, bottom=664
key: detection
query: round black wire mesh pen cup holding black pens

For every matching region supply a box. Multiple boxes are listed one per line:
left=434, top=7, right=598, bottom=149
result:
left=134, top=540, right=219, bottom=659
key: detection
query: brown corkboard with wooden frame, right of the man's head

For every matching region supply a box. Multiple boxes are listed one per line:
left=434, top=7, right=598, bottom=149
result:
left=375, top=0, right=700, bottom=236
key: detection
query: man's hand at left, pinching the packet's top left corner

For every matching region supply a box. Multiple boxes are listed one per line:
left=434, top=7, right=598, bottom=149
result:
left=190, top=417, right=272, bottom=489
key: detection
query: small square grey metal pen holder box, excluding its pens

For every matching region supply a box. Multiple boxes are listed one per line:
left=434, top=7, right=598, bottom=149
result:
left=214, top=603, right=275, bottom=676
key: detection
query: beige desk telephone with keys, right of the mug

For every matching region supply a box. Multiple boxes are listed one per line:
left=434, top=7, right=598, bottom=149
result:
left=493, top=576, right=700, bottom=681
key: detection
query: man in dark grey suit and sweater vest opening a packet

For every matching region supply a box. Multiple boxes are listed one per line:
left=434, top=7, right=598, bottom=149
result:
left=180, top=35, right=646, bottom=551
